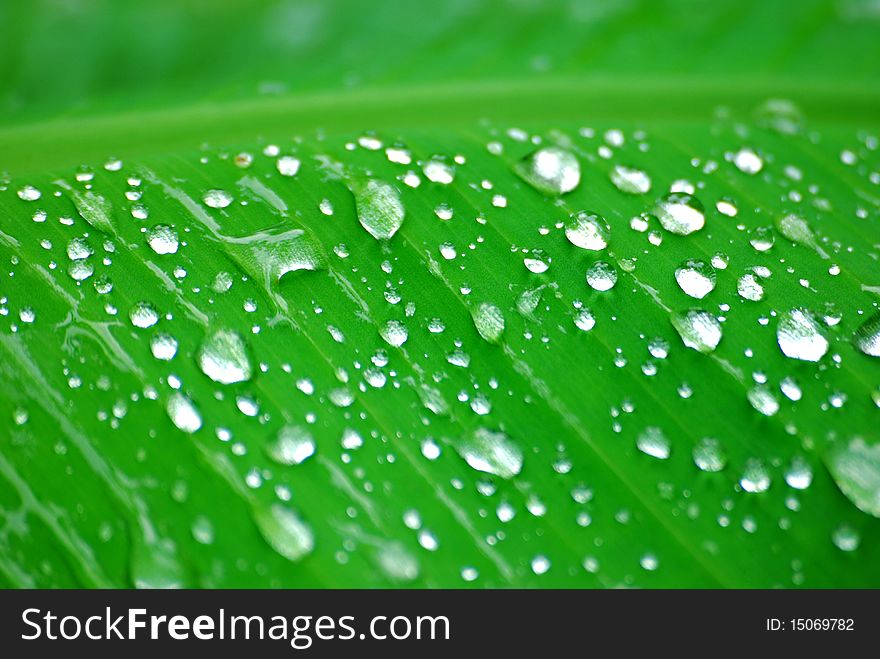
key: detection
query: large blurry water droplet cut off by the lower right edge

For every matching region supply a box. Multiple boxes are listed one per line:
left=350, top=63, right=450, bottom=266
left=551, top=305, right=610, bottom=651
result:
left=828, top=438, right=880, bottom=517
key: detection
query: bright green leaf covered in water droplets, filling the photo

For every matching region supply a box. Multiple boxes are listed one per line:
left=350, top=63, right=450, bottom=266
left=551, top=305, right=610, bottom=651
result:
left=0, top=0, right=880, bottom=587
